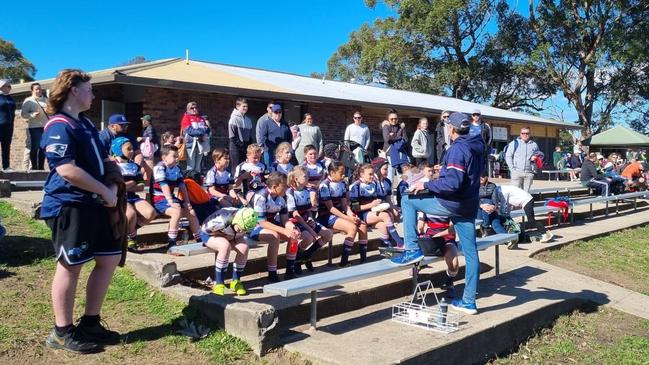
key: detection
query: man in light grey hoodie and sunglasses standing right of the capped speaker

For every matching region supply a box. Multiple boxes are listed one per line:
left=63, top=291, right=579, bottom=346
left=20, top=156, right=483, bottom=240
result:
left=505, top=128, right=542, bottom=192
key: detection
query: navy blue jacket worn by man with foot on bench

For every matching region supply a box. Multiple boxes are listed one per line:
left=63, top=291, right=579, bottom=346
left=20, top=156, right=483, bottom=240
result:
left=424, top=134, right=484, bottom=218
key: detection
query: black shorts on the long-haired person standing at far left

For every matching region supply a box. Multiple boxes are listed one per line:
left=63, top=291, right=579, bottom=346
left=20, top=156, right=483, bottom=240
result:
left=45, top=205, right=122, bottom=265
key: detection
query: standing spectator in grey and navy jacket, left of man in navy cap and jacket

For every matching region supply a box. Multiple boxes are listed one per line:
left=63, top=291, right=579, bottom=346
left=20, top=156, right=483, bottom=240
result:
left=228, top=98, right=253, bottom=171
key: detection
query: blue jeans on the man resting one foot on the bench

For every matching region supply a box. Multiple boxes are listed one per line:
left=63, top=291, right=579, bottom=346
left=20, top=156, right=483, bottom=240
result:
left=401, top=195, right=480, bottom=303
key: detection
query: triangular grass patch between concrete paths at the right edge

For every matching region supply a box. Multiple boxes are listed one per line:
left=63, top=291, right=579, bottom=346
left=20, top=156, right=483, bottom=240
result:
left=535, top=226, right=649, bottom=295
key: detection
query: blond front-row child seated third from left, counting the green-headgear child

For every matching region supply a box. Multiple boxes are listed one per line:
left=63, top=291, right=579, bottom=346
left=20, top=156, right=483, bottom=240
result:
left=286, top=166, right=333, bottom=275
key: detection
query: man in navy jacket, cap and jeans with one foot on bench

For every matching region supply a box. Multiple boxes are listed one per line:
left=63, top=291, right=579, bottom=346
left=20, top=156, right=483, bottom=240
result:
left=392, top=113, right=484, bottom=314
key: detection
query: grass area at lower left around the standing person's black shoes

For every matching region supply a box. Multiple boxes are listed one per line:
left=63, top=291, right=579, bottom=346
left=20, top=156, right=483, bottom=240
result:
left=0, top=201, right=253, bottom=365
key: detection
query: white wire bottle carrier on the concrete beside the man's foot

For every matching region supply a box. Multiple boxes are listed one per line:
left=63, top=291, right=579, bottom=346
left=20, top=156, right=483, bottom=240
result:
left=392, top=281, right=460, bottom=333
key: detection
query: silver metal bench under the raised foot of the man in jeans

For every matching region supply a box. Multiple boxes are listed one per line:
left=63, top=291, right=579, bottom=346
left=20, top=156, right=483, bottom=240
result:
left=264, top=233, right=518, bottom=329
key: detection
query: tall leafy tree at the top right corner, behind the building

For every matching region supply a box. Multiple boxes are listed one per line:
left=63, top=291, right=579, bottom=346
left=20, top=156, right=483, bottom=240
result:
left=529, top=0, right=649, bottom=136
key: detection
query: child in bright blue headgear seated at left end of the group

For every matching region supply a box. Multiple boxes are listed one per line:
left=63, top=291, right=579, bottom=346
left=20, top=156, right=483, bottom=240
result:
left=110, top=137, right=156, bottom=251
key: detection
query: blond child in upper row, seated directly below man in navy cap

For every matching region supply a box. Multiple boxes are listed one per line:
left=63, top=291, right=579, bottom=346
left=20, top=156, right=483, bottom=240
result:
left=234, top=144, right=266, bottom=205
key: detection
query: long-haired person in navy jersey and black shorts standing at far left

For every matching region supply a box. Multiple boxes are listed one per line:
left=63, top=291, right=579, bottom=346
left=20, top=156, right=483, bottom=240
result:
left=41, top=69, right=122, bottom=353
